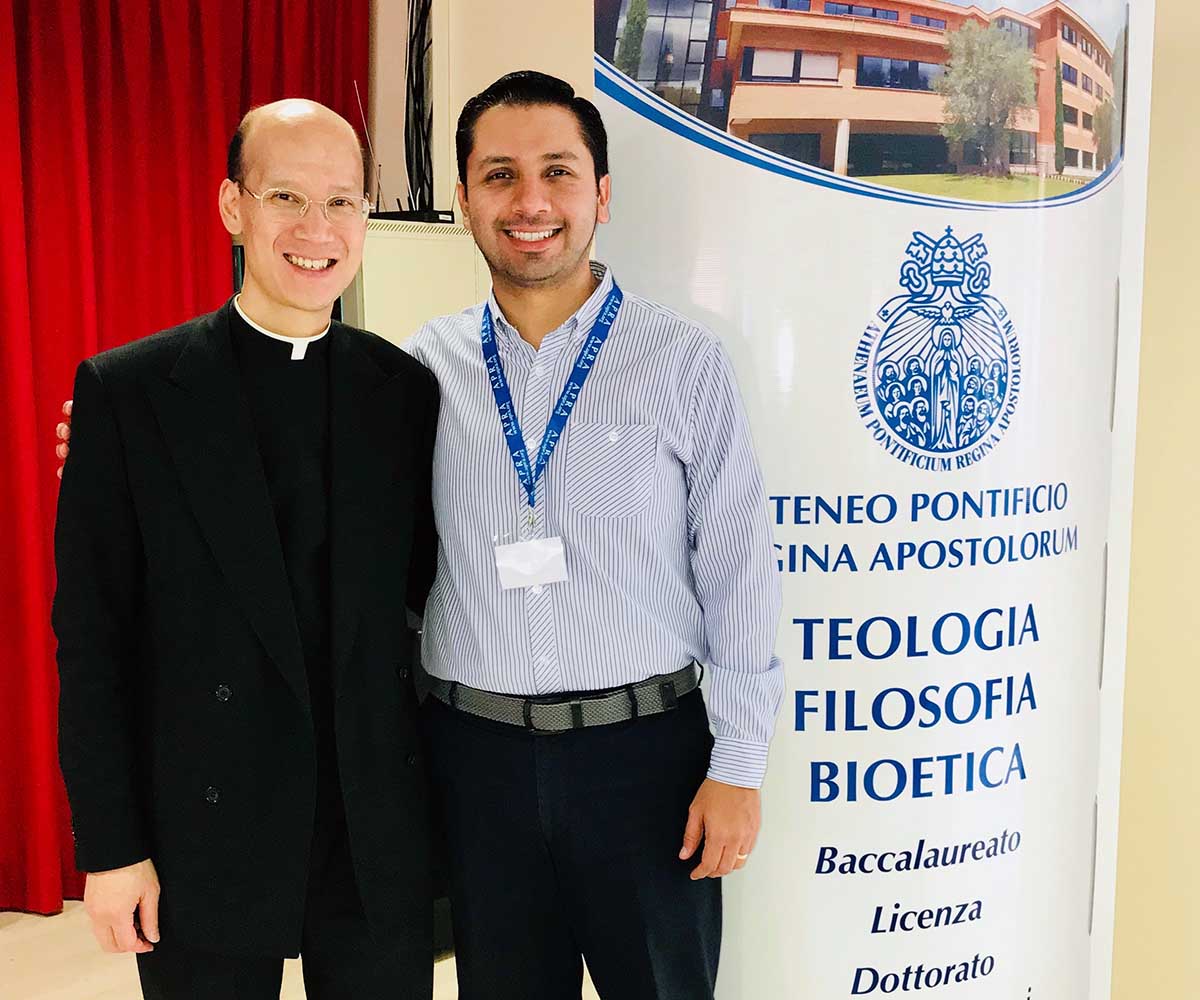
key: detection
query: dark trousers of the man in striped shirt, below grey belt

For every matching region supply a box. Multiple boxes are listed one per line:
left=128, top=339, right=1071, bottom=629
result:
left=425, top=691, right=721, bottom=1000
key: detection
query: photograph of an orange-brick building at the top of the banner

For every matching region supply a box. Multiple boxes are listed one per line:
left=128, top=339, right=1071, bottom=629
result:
left=596, top=0, right=1127, bottom=202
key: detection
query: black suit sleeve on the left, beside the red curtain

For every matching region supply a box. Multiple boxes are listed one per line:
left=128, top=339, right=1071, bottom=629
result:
left=53, top=361, right=151, bottom=872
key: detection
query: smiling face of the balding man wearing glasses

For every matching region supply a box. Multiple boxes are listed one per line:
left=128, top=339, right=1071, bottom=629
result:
left=220, top=101, right=366, bottom=335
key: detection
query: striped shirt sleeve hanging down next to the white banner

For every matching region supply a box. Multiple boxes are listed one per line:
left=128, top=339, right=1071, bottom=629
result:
left=686, top=340, right=784, bottom=788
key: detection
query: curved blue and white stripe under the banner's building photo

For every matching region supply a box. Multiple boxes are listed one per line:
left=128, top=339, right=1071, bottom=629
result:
left=595, top=55, right=1121, bottom=211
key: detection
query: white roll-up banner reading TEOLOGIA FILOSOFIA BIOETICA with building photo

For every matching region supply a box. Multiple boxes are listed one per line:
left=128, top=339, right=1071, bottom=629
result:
left=595, top=0, right=1148, bottom=1000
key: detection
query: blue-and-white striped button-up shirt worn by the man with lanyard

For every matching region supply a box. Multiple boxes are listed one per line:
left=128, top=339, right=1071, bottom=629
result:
left=406, top=264, right=784, bottom=788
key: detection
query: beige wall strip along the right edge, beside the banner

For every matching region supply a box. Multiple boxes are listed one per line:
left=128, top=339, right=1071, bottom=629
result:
left=1112, top=0, right=1200, bottom=1000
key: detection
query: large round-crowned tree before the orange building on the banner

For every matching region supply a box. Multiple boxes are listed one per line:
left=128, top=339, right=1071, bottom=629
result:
left=935, top=20, right=1034, bottom=175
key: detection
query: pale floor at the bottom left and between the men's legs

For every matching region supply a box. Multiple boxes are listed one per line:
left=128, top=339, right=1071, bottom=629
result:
left=0, top=903, right=596, bottom=1000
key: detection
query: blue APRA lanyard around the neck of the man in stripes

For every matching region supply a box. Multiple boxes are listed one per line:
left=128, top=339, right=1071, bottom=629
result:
left=479, top=282, right=624, bottom=508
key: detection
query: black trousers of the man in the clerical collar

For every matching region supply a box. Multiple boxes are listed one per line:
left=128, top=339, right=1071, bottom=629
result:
left=138, top=795, right=433, bottom=1000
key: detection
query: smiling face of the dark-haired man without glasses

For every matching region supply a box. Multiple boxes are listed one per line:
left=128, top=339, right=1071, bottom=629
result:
left=458, top=104, right=611, bottom=288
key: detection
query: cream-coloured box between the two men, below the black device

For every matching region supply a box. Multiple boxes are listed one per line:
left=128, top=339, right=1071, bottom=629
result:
left=342, top=218, right=491, bottom=345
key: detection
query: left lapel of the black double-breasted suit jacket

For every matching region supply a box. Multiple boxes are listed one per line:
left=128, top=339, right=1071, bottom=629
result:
left=150, top=306, right=308, bottom=705
